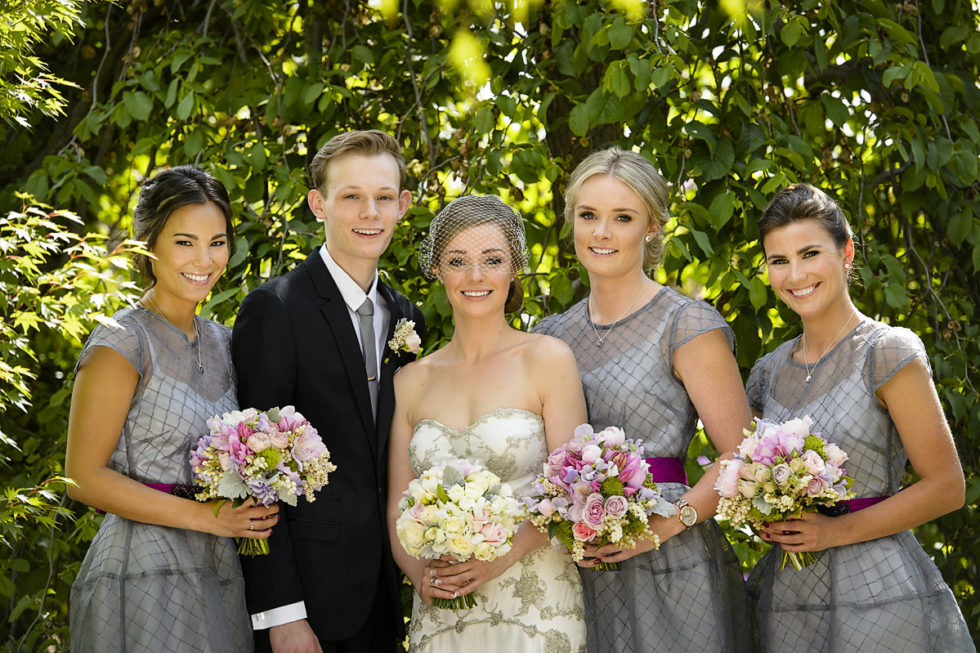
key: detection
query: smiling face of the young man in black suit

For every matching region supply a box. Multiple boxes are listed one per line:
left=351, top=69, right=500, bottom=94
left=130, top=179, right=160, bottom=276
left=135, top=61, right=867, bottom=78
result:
left=307, top=153, right=412, bottom=283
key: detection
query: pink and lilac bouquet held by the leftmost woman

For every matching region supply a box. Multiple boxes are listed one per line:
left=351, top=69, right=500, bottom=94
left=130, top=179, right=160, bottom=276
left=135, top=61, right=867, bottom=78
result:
left=190, top=406, right=337, bottom=555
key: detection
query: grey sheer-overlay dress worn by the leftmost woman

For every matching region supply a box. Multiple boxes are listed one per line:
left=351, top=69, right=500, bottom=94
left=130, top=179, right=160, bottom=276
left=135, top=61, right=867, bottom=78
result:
left=71, top=307, right=252, bottom=653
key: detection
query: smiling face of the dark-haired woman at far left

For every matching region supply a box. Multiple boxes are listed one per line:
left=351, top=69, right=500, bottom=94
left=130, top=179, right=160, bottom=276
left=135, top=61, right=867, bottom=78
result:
left=150, top=202, right=230, bottom=306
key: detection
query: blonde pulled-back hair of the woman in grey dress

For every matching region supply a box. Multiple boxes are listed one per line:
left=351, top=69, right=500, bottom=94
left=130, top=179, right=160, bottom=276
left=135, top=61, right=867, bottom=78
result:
left=565, top=147, right=669, bottom=270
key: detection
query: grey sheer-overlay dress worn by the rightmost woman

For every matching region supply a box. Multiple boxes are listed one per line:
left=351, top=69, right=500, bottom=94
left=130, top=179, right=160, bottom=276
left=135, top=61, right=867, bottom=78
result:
left=747, top=317, right=975, bottom=653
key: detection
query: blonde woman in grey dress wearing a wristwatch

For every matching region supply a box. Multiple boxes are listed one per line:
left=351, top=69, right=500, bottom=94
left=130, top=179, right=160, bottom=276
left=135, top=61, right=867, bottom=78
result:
left=536, top=148, right=750, bottom=653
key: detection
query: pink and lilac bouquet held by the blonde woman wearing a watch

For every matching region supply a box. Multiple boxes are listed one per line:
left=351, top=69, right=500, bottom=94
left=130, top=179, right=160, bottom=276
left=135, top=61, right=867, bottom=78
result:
left=524, top=424, right=677, bottom=569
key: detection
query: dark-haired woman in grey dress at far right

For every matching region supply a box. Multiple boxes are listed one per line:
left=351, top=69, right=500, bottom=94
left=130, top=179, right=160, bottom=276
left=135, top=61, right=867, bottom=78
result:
left=748, top=184, right=975, bottom=653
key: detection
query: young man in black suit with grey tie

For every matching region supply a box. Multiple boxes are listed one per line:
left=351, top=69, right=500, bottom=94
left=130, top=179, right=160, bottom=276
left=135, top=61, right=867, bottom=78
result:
left=231, top=130, right=423, bottom=652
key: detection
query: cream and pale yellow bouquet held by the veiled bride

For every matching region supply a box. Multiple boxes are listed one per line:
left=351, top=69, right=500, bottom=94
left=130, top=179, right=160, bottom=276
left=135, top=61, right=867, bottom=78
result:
left=395, top=460, right=520, bottom=610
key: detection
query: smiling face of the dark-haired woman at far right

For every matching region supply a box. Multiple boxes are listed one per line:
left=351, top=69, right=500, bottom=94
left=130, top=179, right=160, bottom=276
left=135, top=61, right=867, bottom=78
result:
left=762, top=218, right=854, bottom=318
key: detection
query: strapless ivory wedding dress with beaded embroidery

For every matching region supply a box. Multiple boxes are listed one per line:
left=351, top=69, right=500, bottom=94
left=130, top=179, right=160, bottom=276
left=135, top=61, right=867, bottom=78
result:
left=409, top=408, right=585, bottom=653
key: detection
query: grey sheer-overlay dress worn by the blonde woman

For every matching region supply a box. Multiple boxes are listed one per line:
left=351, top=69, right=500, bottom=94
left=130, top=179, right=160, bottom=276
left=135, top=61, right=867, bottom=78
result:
left=535, top=287, right=750, bottom=653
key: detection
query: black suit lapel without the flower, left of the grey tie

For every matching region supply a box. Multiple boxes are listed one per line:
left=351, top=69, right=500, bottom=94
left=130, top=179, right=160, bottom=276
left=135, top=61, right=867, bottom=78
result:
left=305, top=250, right=377, bottom=444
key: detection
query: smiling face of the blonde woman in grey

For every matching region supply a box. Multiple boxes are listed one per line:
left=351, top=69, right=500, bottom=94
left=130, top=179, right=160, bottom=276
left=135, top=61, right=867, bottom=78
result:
left=572, top=174, right=657, bottom=277
